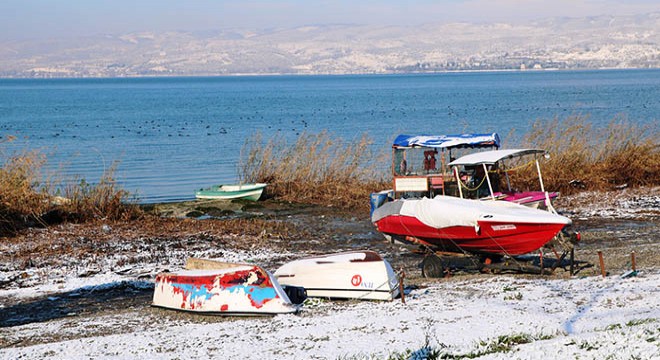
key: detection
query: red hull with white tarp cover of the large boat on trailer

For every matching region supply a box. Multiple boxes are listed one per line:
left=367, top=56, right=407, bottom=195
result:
left=371, top=195, right=572, bottom=256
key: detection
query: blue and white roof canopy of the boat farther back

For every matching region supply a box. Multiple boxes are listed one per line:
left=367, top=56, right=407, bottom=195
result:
left=392, top=133, right=500, bottom=149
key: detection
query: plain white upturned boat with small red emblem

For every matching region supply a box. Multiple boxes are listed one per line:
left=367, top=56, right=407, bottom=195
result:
left=273, top=251, right=399, bottom=300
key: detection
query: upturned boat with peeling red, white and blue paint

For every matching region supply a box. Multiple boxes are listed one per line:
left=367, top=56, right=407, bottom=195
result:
left=153, top=259, right=298, bottom=315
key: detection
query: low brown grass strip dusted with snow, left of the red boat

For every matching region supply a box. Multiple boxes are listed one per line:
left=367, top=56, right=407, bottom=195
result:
left=0, top=216, right=311, bottom=268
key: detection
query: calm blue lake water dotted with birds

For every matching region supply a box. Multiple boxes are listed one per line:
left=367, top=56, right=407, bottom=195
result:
left=0, top=70, right=660, bottom=202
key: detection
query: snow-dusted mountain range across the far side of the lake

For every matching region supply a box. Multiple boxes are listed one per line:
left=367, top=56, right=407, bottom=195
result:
left=0, top=13, right=660, bottom=78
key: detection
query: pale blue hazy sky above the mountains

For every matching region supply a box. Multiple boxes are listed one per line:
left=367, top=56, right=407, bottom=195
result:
left=0, top=0, right=660, bottom=40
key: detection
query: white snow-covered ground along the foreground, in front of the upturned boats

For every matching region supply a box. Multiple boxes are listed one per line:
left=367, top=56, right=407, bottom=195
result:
left=0, top=269, right=660, bottom=359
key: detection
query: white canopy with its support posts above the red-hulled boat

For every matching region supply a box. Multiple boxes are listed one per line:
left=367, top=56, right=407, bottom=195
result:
left=449, top=149, right=559, bottom=211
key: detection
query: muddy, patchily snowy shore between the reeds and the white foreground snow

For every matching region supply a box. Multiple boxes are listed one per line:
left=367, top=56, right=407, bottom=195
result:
left=0, top=187, right=660, bottom=348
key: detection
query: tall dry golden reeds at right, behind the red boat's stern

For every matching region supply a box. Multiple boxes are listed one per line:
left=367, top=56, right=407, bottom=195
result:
left=523, top=116, right=660, bottom=194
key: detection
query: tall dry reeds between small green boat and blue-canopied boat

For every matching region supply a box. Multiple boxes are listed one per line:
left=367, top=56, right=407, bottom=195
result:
left=239, top=131, right=390, bottom=210
